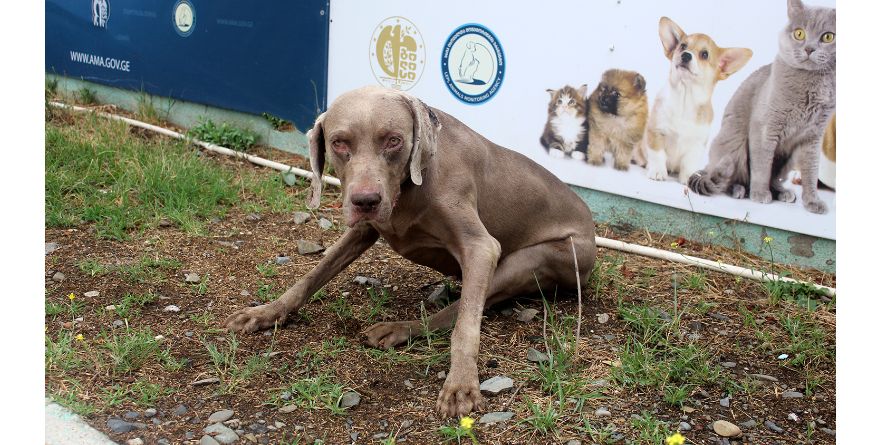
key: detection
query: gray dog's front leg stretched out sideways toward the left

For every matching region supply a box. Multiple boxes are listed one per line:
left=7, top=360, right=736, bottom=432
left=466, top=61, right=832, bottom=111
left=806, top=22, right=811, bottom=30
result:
left=224, top=224, right=379, bottom=332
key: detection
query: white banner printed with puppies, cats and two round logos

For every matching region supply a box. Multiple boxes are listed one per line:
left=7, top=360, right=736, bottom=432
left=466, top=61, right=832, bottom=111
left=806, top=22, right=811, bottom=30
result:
left=328, top=0, right=836, bottom=239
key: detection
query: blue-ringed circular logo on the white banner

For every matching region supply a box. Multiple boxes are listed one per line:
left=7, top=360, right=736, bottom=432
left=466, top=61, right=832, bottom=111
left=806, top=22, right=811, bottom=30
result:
left=441, top=23, right=505, bottom=105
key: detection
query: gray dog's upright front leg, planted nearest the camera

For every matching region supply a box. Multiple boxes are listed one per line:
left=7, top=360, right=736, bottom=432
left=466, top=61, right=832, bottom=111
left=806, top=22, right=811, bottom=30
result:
left=437, top=225, right=501, bottom=417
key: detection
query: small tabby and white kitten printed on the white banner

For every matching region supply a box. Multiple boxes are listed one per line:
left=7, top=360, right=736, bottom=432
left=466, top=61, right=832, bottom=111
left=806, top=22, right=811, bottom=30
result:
left=541, top=85, right=588, bottom=161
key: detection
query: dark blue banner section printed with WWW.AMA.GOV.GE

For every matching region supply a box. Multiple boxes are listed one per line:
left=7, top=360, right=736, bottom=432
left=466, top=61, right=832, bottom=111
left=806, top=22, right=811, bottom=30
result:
left=46, top=0, right=329, bottom=131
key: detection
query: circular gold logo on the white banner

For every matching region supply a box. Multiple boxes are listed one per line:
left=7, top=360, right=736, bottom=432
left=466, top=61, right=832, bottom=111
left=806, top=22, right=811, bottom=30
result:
left=369, top=16, right=425, bottom=91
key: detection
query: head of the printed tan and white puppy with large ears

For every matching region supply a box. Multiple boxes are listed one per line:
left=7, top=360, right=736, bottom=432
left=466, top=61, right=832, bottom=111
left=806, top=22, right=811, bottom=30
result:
left=658, top=17, right=753, bottom=91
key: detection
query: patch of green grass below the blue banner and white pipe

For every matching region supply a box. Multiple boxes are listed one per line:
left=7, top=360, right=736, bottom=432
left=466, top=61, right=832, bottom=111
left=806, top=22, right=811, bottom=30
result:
left=45, top=115, right=302, bottom=240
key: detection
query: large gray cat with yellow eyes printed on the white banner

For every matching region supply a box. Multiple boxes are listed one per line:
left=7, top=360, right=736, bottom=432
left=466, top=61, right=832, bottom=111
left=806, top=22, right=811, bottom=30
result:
left=689, top=0, right=837, bottom=213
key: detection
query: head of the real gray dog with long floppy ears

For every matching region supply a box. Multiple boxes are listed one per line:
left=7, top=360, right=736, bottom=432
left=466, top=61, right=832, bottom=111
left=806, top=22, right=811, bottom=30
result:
left=308, top=87, right=440, bottom=227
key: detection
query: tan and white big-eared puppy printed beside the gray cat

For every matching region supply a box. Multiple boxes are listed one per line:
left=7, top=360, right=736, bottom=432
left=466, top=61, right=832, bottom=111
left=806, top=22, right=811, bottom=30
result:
left=641, top=17, right=753, bottom=184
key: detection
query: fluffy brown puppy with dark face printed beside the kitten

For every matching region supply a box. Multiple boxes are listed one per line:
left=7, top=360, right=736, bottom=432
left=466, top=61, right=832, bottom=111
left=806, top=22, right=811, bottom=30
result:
left=588, top=69, right=649, bottom=170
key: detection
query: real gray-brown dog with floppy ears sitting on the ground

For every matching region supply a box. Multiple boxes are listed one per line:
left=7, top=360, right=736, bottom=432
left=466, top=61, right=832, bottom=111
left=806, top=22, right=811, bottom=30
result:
left=225, top=87, right=597, bottom=416
